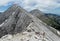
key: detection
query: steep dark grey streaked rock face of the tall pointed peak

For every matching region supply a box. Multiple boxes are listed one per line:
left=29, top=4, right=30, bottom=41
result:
left=0, top=5, right=32, bottom=37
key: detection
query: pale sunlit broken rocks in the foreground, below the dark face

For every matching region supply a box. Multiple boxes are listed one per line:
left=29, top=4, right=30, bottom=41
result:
left=0, top=23, right=52, bottom=41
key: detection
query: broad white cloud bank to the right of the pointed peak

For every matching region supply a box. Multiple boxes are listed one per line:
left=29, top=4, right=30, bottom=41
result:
left=17, top=0, right=60, bottom=10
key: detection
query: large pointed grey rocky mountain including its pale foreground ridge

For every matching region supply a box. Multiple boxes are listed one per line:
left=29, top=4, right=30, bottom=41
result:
left=0, top=4, right=60, bottom=41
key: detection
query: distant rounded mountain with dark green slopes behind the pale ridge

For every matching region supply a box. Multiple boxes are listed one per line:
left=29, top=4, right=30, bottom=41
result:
left=30, top=9, right=60, bottom=30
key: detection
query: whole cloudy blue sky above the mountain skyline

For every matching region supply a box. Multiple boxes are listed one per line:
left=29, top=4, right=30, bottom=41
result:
left=0, top=0, right=60, bottom=15
